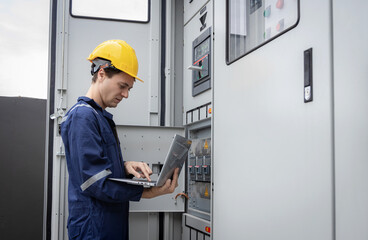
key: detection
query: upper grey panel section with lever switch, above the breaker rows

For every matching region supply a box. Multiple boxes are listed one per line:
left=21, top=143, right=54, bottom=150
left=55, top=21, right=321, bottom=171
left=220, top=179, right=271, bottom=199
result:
left=183, top=0, right=213, bottom=125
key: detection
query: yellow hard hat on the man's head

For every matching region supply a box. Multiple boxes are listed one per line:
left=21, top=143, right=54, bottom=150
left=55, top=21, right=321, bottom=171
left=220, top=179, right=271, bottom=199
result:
left=88, top=40, right=143, bottom=82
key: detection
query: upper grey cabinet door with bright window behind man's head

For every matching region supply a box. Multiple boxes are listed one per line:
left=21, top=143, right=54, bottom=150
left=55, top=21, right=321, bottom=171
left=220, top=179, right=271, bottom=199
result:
left=56, top=0, right=160, bottom=126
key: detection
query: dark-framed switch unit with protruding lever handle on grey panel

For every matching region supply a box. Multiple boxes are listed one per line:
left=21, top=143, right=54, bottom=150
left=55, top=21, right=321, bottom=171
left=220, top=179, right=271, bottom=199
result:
left=192, top=28, right=211, bottom=97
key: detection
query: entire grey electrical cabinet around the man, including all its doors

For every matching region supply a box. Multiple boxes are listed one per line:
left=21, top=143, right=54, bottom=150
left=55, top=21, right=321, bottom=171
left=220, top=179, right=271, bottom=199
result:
left=44, top=0, right=368, bottom=240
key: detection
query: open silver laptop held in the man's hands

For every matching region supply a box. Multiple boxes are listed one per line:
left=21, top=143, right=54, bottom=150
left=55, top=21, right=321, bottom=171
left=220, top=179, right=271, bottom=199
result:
left=109, top=134, right=192, bottom=187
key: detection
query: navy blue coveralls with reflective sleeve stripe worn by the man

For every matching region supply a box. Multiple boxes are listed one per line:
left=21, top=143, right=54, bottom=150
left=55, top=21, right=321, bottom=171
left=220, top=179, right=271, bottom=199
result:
left=61, top=97, right=143, bottom=240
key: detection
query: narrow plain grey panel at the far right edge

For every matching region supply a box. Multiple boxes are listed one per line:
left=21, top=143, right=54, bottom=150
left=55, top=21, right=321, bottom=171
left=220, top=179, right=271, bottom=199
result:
left=333, top=0, right=368, bottom=240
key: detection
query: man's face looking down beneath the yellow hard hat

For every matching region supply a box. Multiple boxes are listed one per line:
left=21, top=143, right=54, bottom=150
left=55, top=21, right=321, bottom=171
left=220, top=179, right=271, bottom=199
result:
left=100, top=72, right=134, bottom=109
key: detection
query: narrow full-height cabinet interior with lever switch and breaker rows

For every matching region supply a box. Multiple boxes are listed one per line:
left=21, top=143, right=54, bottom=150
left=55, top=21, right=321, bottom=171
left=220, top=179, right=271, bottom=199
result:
left=182, top=1, right=213, bottom=240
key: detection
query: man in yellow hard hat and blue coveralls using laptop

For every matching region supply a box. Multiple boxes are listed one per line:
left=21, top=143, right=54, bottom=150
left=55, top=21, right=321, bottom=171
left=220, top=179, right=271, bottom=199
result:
left=61, top=40, right=178, bottom=240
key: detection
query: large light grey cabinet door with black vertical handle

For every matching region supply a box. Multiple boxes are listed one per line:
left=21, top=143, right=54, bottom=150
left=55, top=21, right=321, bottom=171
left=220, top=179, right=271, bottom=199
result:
left=212, top=0, right=334, bottom=240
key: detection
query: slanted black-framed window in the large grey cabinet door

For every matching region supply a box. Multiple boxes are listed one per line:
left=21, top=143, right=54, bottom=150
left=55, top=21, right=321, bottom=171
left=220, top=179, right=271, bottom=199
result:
left=226, top=0, right=300, bottom=64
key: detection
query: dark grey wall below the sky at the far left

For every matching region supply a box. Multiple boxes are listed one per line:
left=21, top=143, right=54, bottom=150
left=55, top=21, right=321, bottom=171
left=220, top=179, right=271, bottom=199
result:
left=0, top=97, right=46, bottom=240
